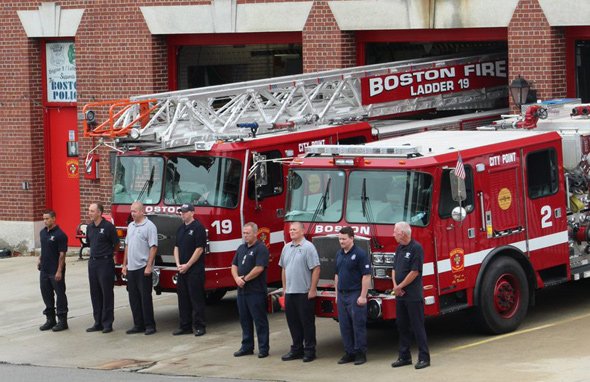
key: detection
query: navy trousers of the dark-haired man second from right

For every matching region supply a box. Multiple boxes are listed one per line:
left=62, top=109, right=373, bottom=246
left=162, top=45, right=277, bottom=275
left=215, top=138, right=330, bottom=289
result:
left=338, top=290, right=367, bottom=354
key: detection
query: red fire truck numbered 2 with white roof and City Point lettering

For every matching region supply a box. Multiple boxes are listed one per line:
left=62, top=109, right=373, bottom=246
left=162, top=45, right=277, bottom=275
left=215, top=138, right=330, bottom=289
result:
left=285, top=99, right=590, bottom=333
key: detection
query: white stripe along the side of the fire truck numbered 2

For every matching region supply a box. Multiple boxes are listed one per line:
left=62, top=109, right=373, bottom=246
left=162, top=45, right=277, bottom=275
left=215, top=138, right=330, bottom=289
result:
left=430, top=231, right=568, bottom=276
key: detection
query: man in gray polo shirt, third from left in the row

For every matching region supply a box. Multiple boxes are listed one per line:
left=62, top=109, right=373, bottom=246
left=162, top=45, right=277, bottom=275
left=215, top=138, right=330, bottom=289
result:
left=122, top=202, right=158, bottom=335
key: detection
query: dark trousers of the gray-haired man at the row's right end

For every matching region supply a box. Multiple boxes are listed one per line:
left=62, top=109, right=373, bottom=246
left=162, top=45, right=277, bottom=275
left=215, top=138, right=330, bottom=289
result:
left=396, top=300, right=430, bottom=361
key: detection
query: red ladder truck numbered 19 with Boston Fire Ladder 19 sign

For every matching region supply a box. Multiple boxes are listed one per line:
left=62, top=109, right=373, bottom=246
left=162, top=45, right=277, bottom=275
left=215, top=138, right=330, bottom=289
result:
left=83, top=55, right=507, bottom=301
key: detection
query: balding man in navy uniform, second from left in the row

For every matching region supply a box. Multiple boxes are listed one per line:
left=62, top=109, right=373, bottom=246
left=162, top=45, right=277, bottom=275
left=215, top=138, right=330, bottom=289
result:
left=86, top=203, right=119, bottom=333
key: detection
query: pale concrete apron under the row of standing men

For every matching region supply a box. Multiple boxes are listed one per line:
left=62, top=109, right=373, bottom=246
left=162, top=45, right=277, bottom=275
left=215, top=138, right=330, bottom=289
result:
left=0, top=257, right=590, bottom=382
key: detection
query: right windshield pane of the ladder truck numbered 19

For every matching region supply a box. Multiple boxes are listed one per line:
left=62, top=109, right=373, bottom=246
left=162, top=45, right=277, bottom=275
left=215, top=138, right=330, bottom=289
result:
left=164, top=156, right=242, bottom=208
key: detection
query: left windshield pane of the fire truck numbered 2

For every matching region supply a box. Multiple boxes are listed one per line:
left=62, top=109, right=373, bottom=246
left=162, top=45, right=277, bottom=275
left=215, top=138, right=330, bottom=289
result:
left=285, top=170, right=345, bottom=222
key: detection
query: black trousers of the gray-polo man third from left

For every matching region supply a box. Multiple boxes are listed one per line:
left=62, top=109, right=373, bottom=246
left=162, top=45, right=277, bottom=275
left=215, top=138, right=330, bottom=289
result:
left=127, top=267, right=156, bottom=329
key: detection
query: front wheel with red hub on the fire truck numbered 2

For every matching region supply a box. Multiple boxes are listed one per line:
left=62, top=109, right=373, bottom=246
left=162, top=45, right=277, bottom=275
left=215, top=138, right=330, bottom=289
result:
left=477, top=257, right=529, bottom=334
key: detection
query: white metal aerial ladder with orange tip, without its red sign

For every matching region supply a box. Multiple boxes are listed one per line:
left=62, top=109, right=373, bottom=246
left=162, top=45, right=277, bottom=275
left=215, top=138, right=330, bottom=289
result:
left=83, top=54, right=508, bottom=150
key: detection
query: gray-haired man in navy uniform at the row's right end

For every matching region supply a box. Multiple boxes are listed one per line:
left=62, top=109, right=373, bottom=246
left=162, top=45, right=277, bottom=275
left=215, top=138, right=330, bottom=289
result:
left=391, top=222, right=430, bottom=369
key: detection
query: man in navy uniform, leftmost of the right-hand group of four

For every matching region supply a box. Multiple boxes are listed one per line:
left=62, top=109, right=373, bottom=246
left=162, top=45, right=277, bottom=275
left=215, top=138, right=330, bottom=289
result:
left=231, top=223, right=269, bottom=358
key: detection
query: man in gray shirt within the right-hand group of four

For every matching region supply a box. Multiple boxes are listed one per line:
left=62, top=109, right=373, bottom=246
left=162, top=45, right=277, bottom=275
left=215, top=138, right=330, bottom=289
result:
left=279, top=222, right=320, bottom=362
